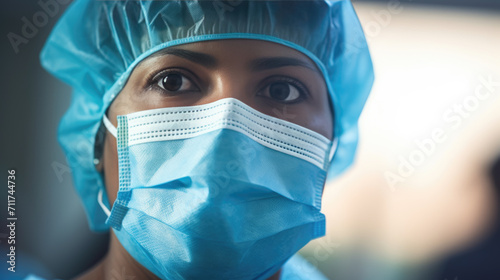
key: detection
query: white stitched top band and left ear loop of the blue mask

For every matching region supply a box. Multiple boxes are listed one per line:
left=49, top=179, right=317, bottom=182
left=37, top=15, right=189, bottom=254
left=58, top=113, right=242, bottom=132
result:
left=98, top=98, right=336, bottom=216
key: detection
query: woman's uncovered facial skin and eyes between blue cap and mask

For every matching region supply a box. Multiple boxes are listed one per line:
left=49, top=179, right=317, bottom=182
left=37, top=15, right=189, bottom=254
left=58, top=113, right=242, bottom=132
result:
left=103, top=40, right=333, bottom=204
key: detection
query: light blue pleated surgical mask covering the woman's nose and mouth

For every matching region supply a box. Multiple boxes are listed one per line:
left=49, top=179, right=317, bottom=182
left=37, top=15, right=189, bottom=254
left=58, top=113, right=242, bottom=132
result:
left=99, top=98, right=334, bottom=280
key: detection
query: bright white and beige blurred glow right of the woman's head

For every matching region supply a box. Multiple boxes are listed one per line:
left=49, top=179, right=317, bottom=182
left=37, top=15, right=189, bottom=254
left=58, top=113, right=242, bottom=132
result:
left=303, top=1, right=500, bottom=280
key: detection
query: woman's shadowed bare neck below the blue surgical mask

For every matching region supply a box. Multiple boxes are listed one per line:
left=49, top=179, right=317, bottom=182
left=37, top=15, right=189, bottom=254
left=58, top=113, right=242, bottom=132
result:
left=74, top=230, right=281, bottom=280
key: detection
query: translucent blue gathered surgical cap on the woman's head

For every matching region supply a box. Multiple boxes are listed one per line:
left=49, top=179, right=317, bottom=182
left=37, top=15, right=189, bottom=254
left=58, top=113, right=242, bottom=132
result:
left=41, top=0, right=373, bottom=231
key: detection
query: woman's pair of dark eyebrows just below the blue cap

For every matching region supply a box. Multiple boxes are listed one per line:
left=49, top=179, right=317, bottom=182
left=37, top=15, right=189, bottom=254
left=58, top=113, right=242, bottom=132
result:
left=152, top=48, right=319, bottom=73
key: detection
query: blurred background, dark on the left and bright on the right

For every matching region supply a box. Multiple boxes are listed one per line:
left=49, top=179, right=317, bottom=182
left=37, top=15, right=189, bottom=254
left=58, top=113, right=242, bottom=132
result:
left=0, top=0, right=500, bottom=280
